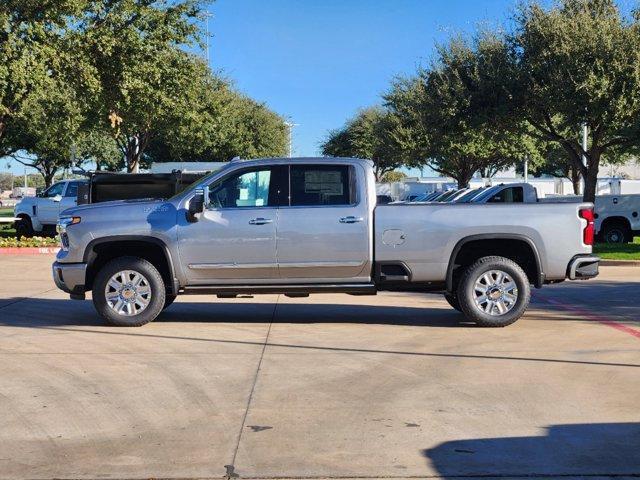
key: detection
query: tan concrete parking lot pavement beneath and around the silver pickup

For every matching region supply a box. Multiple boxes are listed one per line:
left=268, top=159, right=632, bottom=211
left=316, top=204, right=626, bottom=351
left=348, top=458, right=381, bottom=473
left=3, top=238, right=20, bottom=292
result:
left=0, top=256, right=640, bottom=479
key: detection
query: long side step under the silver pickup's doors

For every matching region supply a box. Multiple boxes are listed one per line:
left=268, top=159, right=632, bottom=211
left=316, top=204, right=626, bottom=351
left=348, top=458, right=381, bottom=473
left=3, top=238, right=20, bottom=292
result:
left=179, top=283, right=377, bottom=298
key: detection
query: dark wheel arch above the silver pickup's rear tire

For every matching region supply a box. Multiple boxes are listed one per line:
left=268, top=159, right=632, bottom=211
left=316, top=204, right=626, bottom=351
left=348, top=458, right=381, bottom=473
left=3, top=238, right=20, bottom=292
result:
left=446, top=233, right=545, bottom=292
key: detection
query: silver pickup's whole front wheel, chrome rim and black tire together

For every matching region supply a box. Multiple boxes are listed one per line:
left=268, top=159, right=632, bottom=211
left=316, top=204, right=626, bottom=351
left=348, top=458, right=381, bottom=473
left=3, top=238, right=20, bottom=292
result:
left=93, top=257, right=166, bottom=327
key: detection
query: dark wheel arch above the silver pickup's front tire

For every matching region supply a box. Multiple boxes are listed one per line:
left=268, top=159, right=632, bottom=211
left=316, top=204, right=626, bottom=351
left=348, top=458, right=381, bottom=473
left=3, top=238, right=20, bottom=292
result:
left=83, top=235, right=179, bottom=294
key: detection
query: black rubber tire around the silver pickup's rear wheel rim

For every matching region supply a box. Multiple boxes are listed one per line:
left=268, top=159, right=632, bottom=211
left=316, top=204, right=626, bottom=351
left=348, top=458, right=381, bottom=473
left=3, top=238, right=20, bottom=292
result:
left=457, top=256, right=531, bottom=327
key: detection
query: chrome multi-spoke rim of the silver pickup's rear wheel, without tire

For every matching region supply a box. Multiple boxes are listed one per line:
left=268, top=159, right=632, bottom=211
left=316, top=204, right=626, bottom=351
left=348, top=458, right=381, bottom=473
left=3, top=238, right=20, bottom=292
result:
left=473, top=270, right=518, bottom=317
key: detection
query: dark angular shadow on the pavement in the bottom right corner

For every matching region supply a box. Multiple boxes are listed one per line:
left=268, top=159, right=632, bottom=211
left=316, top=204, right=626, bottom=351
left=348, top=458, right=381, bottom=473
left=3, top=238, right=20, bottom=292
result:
left=422, top=423, right=640, bottom=478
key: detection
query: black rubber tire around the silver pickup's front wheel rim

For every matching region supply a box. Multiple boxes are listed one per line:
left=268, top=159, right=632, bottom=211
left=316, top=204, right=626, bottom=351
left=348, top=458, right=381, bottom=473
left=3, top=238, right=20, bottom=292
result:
left=92, top=257, right=166, bottom=327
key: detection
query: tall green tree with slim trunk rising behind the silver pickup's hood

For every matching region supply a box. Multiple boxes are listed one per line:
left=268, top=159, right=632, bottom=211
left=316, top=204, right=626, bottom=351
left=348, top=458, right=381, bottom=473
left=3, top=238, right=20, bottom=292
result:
left=70, top=0, right=205, bottom=172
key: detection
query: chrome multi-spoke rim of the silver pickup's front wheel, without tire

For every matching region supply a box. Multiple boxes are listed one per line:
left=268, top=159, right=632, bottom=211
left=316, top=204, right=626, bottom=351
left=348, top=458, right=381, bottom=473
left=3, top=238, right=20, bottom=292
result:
left=104, top=270, right=151, bottom=317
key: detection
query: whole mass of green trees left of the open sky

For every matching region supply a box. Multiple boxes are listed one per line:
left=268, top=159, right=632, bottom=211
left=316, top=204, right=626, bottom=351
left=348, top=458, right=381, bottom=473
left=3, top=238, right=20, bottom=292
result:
left=0, top=0, right=287, bottom=182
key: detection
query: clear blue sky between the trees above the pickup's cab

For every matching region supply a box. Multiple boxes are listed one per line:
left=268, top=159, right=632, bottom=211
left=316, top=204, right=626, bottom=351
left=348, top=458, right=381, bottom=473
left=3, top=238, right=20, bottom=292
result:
left=209, top=0, right=516, bottom=156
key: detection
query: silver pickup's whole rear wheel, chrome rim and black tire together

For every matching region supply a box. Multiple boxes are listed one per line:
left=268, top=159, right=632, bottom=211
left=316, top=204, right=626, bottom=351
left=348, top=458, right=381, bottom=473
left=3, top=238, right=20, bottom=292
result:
left=457, top=256, right=531, bottom=327
